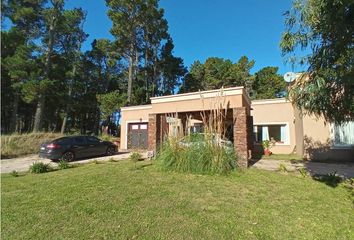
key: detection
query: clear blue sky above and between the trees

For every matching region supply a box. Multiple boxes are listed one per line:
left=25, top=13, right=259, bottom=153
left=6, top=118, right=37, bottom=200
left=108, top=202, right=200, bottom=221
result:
left=66, top=0, right=303, bottom=74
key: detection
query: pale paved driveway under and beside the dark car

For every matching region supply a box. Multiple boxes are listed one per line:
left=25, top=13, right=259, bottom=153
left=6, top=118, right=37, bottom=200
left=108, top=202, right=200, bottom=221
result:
left=0, top=152, right=146, bottom=173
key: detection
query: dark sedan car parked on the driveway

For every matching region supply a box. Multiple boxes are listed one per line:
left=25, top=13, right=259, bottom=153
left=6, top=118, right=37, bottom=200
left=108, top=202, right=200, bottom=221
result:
left=39, top=136, right=117, bottom=161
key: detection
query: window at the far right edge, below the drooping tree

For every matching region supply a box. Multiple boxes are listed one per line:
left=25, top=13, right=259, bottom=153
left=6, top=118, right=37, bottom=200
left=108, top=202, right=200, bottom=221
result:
left=333, top=121, right=354, bottom=147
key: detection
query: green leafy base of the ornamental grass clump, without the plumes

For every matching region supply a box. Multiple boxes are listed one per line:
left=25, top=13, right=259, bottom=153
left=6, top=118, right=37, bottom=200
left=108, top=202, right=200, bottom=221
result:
left=156, top=139, right=237, bottom=174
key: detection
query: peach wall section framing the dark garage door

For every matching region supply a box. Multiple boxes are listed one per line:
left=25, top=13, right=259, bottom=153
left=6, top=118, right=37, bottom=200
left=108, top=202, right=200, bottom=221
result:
left=120, top=105, right=151, bottom=150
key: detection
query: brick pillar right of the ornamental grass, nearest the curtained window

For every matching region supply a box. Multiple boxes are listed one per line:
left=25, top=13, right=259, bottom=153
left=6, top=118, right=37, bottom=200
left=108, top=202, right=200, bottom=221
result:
left=233, top=107, right=253, bottom=168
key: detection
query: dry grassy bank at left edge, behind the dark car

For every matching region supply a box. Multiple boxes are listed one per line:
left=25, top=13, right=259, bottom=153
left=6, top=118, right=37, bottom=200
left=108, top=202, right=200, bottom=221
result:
left=1, top=133, right=63, bottom=158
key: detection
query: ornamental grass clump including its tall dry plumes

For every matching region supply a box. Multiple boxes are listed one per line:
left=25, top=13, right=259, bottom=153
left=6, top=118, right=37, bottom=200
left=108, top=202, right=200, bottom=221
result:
left=156, top=90, right=237, bottom=174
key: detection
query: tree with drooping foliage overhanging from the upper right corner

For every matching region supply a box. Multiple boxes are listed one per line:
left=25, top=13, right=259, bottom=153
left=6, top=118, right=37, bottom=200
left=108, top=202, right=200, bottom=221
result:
left=280, top=0, right=354, bottom=123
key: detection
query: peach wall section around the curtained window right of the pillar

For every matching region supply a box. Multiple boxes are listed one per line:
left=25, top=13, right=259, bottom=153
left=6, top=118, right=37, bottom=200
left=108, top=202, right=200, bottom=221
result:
left=251, top=99, right=296, bottom=154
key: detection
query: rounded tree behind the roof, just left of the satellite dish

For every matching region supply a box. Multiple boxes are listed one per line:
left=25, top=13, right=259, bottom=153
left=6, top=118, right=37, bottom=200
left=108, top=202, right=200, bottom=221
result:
left=253, top=67, right=286, bottom=99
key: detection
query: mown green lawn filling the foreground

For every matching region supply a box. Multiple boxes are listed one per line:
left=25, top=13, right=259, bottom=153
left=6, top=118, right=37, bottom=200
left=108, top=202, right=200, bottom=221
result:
left=1, top=161, right=354, bottom=239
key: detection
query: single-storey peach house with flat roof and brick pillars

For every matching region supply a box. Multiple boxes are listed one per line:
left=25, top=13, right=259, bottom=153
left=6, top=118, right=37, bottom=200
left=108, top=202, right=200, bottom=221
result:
left=121, top=87, right=354, bottom=167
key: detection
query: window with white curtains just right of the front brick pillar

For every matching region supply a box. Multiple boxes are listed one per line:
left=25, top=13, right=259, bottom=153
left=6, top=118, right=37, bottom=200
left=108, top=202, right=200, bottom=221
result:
left=254, top=124, right=289, bottom=144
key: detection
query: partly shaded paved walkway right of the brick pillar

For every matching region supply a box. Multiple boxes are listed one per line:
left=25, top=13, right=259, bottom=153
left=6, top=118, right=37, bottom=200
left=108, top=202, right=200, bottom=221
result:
left=252, top=159, right=354, bottom=178
